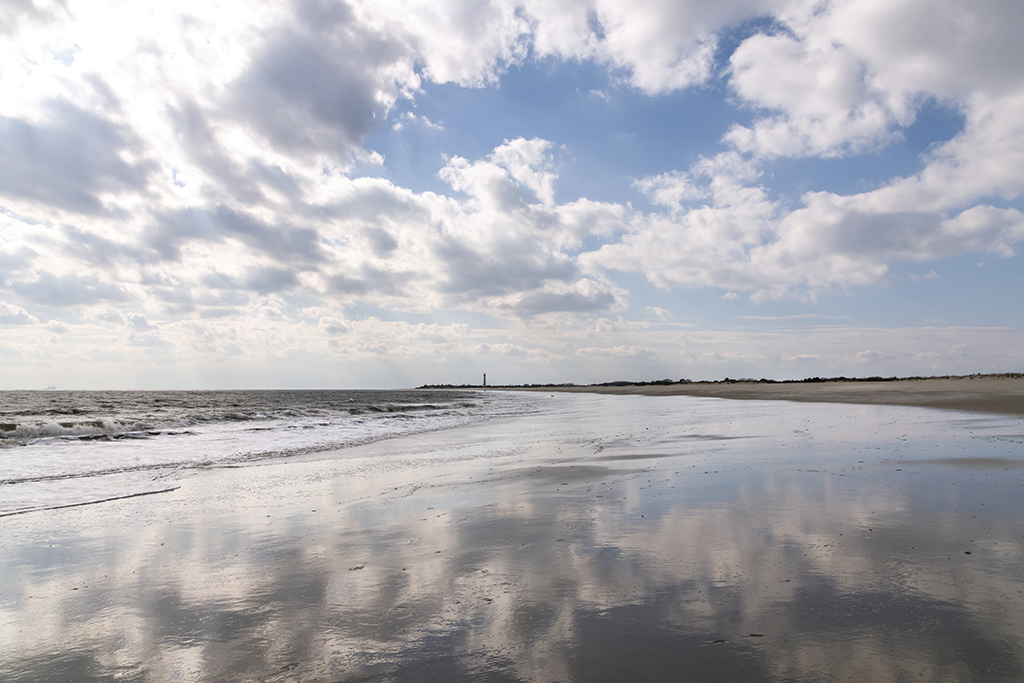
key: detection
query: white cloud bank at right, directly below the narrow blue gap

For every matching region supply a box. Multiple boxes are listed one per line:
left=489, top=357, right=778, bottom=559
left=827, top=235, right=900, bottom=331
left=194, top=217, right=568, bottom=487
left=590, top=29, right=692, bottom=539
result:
left=580, top=148, right=1024, bottom=299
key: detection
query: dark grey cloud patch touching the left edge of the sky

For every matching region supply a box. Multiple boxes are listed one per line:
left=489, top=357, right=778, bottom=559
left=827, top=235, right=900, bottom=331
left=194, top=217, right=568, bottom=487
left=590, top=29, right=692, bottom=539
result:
left=0, top=101, right=153, bottom=214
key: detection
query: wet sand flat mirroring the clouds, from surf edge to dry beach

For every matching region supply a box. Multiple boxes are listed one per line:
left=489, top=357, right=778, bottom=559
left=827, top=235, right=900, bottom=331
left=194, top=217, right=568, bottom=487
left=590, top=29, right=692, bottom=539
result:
left=0, top=394, right=1024, bottom=681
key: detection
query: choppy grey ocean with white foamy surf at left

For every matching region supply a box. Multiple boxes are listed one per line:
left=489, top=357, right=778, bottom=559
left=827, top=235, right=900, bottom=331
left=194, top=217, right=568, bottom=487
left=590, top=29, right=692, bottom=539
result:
left=0, top=389, right=539, bottom=516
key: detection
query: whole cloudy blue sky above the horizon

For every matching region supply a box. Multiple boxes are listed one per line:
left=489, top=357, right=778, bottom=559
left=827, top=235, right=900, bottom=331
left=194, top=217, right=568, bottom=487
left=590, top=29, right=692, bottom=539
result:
left=0, top=0, right=1024, bottom=389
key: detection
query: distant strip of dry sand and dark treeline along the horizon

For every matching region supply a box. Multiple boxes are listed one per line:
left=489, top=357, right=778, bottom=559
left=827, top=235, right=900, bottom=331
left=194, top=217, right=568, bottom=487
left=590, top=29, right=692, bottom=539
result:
left=419, top=373, right=1024, bottom=416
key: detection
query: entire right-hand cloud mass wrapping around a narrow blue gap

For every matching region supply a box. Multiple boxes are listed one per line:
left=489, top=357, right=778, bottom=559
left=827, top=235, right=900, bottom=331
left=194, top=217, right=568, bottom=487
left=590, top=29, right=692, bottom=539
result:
left=581, top=2, right=1024, bottom=300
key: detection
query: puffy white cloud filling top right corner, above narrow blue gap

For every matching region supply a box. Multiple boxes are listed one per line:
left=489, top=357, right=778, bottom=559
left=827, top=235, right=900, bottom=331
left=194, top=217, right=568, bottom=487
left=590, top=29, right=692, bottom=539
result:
left=726, top=0, right=1024, bottom=162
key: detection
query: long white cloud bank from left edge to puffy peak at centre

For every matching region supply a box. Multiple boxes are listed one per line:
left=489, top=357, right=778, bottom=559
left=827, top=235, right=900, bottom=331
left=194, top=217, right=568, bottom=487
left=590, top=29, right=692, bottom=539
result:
left=0, top=133, right=626, bottom=329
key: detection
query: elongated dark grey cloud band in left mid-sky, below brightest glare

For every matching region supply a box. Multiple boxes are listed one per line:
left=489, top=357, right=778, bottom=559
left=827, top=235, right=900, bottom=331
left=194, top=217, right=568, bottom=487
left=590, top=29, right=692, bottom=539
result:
left=144, top=207, right=326, bottom=263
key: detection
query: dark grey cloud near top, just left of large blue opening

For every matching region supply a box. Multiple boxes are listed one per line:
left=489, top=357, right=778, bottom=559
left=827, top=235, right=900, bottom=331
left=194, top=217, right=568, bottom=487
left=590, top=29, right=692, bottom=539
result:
left=226, top=7, right=408, bottom=155
